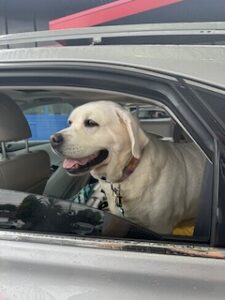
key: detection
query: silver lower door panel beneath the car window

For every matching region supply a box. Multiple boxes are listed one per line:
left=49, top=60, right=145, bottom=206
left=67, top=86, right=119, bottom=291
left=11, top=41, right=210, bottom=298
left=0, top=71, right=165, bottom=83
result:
left=0, top=240, right=225, bottom=300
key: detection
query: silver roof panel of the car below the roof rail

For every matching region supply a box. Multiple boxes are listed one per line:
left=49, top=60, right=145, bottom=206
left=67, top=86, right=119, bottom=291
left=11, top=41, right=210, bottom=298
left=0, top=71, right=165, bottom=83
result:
left=0, top=45, right=225, bottom=88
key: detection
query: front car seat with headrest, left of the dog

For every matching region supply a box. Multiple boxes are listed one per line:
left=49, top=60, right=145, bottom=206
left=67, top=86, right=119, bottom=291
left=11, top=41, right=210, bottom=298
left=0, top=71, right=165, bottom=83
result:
left=0, top=93, right=50, bottom=194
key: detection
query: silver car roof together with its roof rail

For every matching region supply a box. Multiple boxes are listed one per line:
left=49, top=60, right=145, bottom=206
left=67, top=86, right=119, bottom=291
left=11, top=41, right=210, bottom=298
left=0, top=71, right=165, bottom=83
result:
left=0, top=22, right=225, bottom=88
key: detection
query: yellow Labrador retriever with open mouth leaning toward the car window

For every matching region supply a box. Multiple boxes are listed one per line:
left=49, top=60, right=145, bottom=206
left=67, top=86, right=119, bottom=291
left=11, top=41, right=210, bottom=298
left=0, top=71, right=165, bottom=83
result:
left=50, top=101, right=204, bottom=234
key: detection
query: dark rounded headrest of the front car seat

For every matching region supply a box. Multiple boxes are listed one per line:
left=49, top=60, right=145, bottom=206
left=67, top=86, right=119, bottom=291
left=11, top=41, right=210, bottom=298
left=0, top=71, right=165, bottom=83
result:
left=0, top=93, right=31, bottom=142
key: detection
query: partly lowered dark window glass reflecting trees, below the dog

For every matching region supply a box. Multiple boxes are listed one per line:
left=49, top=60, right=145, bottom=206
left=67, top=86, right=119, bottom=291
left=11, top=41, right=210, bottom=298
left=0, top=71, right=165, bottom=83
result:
left=0, top=190, right=160, bottom=240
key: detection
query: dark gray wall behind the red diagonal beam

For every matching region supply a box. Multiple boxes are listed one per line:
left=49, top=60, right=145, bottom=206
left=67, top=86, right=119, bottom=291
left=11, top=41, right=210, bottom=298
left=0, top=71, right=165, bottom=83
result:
left=0, top=0, right=225, bottom=34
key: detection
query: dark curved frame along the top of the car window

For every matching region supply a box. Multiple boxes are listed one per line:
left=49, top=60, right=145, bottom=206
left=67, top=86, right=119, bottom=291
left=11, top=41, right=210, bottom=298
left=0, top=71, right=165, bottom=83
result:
left=0, top=62, right=218, bottom=245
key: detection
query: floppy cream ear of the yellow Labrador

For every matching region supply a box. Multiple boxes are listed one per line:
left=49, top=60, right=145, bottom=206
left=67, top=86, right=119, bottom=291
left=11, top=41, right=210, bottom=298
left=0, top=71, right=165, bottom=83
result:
left=116, top=109, right=149, bottom=159
